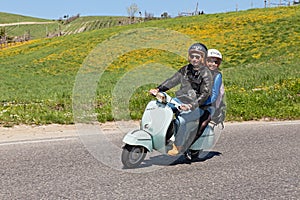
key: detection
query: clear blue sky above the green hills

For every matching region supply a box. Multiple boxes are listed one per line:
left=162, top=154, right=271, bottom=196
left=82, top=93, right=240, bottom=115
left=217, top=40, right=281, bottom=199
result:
left=0, top=0, right=280, bottom=19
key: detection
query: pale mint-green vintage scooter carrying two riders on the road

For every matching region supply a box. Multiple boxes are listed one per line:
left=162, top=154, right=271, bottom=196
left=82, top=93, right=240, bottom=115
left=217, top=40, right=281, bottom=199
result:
left=121, top=92, right=215, bottom=168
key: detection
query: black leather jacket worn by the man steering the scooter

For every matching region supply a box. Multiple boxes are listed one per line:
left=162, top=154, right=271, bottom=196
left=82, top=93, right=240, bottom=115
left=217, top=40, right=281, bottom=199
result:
left=158, top=64, right=213, bottom=109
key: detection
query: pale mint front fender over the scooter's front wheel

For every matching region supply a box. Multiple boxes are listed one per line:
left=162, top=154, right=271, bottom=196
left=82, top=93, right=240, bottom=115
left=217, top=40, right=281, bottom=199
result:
left=123, top=130, right=153, bottom=152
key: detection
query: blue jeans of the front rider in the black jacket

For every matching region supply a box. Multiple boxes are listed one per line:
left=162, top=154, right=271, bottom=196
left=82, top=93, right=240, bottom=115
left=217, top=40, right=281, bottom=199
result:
left=175, top=108, right=204, bottom=146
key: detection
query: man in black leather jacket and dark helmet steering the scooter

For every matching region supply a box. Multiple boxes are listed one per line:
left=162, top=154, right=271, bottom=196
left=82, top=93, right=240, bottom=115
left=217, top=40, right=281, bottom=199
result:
left=150, top=43, right=213, bottom=156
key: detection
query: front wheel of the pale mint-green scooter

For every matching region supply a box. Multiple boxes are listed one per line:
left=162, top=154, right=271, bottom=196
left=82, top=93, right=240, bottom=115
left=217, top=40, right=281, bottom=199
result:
left=122, top=144, right=147, bottom=168
